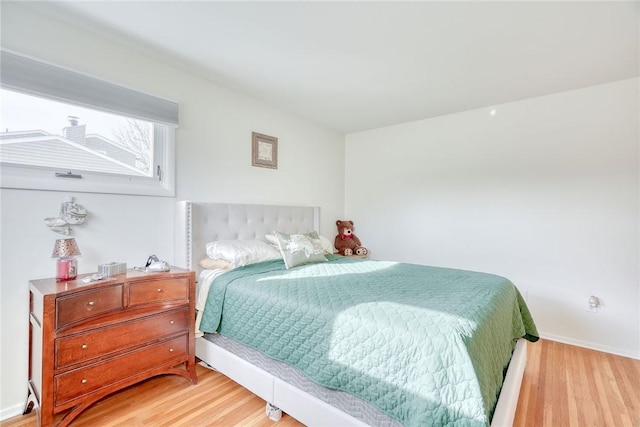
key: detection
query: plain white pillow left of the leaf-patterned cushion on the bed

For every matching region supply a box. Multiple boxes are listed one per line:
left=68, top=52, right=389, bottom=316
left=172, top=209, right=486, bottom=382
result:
left=207, top=240, right=281, bottom=268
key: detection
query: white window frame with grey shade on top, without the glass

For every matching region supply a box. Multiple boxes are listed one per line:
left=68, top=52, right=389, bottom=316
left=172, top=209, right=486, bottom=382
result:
left=0, top=49, right=178, bottom=197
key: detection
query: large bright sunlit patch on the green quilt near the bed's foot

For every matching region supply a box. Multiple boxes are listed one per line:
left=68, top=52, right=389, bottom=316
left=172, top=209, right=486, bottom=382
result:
left=327, top=301, right=485, bottom=425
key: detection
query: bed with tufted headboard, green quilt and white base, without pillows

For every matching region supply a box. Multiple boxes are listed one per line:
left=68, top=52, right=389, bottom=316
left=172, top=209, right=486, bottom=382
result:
left=175, top=201, right=537, bottom=426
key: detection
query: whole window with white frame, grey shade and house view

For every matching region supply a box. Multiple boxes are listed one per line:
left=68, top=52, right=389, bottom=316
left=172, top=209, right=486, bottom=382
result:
left=0, top=51, right=178, bottom=196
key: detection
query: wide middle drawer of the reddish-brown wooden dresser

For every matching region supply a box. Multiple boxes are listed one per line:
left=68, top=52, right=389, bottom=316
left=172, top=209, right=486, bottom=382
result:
left=56, top=308, right=189, bottom=369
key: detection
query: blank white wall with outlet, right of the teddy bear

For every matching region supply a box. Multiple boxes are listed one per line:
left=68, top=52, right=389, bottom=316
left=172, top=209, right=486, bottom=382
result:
left=345, top=79, right=640, bottom=358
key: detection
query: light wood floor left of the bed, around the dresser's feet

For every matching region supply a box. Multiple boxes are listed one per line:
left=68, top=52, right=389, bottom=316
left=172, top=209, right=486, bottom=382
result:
left=0, top=365, right=302, bottom=427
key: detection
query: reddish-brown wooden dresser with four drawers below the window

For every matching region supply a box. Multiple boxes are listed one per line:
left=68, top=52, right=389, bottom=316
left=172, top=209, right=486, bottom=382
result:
left=25, top=268, right=197, bottom=427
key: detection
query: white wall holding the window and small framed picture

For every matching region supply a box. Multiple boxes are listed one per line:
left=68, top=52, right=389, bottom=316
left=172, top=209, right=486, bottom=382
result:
left=0, top=2, right=344, bottom=419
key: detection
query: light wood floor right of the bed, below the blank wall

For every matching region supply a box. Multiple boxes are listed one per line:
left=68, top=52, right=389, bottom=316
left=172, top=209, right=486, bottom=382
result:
left=514, top=340, right=640, bottom=427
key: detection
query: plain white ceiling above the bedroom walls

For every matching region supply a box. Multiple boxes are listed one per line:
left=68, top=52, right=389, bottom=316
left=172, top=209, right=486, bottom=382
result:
left=31, top=1, right=640, bottom=133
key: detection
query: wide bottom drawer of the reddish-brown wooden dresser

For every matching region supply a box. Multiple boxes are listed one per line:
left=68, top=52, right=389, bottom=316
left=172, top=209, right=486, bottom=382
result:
left=54, top=335, right=189, bottom=405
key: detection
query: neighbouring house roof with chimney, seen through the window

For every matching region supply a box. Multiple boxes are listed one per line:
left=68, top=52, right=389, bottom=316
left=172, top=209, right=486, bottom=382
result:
left=0, top=130, right=145, bottom=176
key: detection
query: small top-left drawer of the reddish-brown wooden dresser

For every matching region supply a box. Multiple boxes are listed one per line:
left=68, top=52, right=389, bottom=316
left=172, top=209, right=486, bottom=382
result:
left=56, top=284, right=123, bottom=328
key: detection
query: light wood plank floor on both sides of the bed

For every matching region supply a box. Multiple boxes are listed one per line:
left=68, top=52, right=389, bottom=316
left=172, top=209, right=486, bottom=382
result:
left=0, top=340, right=640, bottom=427
